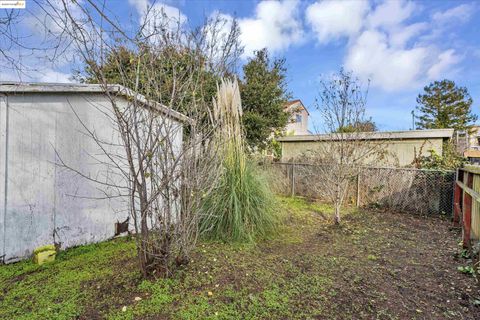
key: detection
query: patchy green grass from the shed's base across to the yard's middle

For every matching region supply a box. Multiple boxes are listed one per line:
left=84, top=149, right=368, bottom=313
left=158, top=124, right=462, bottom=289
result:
left=0, top=198, right=329, bottom=319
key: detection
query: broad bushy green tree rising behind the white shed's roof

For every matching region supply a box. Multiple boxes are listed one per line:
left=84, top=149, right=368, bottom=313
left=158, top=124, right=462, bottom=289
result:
left=76, top=45, right=220, bottom=116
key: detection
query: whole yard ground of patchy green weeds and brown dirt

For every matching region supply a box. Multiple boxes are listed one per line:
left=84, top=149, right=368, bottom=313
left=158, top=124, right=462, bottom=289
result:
left=0, top=198, right=480, bottom=319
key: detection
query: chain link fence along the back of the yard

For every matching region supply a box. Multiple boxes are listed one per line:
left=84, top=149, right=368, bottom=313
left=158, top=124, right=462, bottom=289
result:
left=264, top=163, right=455, bottom=215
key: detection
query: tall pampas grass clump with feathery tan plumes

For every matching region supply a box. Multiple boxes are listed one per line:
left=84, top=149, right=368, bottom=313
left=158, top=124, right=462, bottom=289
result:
left=200, top=80, right=276, bottom=241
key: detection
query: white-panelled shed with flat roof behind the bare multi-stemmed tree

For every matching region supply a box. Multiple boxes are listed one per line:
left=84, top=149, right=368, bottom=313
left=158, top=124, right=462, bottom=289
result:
left=0, top=83, right=188, bottom=263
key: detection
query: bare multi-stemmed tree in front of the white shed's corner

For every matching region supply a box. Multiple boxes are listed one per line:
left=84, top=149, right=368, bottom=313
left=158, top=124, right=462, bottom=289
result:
left=23, top=0, right=241, bottom=276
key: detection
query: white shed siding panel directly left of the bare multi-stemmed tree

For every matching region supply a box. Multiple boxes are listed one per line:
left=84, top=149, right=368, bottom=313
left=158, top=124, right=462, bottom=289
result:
left=55, top=95, right=128, bottom=247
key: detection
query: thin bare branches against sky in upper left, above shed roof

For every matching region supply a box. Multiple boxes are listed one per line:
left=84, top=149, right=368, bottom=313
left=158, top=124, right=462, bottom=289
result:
left=0, top=0, right=82, bottom=80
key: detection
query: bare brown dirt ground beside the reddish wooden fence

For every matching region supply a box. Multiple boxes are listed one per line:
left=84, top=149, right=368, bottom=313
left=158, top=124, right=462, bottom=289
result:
left=308, top=204, right=480, bottom=319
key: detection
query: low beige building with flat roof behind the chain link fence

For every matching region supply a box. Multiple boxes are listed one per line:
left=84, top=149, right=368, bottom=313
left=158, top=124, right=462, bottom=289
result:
left=278, top=129, right=453, bottom=167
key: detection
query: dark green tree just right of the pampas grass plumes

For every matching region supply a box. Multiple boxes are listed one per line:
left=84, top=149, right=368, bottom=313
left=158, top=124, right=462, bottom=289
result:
left=240, top=49, right=289, bottom=150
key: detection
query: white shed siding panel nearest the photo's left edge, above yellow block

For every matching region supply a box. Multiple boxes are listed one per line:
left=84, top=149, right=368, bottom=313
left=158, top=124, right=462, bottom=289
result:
left=5, top=95, right=55, bottom=260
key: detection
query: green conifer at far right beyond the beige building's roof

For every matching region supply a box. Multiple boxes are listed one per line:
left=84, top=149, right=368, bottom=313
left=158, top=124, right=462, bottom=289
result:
left=416, top=79, right=477, bottom=130
